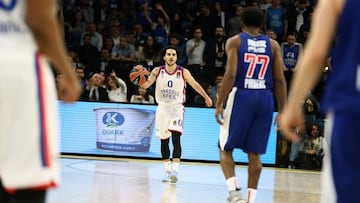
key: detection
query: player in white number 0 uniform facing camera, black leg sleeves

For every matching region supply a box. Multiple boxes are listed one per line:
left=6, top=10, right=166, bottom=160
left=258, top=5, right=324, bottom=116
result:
left=141, top=46, right=212, bottom=183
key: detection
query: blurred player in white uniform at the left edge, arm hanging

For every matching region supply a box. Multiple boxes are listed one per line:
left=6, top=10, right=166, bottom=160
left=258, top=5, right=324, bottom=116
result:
left=0, top=0, right=80, bottom=203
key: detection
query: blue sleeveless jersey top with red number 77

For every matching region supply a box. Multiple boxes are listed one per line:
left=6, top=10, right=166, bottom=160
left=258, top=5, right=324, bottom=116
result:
left=234, top=33, right=273, bottom=89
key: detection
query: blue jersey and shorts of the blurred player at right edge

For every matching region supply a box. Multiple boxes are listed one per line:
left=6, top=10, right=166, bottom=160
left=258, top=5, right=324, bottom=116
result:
left=322, top=0, right=360, bottom=203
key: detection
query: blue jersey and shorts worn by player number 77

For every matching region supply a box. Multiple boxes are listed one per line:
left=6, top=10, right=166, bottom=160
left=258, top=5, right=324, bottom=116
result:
left=219, top=33, right=274, bottom=154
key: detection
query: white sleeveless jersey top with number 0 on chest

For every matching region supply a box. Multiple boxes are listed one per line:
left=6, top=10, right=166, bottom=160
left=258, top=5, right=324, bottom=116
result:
left=155, top=65, right=186, bottom=104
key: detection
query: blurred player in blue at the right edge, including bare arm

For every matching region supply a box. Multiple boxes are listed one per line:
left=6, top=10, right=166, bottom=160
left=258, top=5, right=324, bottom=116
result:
left=279, top=0, right=360, bottom=203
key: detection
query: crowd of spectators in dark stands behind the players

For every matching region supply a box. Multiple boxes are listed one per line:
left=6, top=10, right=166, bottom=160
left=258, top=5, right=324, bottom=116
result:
left=60, top=0, right=331, bottom=168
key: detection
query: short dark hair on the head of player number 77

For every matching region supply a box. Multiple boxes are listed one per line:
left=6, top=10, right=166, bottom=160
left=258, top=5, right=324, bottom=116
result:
left=241, top=6, right=265, bottom=27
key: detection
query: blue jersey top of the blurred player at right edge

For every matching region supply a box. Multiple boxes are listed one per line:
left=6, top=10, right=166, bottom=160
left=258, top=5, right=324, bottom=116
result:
left=322, top=0, right=360, bottom=114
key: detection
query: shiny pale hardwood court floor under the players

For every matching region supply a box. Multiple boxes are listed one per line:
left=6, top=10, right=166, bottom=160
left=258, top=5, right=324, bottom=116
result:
left=47, top=157, right=320, bottom=203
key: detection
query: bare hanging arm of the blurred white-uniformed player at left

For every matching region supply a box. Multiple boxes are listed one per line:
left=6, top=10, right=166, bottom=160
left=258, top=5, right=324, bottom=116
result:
left=26, top=0, right=81, bottom=102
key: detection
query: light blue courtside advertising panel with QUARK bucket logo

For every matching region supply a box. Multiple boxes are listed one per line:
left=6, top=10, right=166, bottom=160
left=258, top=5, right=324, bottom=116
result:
left=59, top=102, right=276, bottom=164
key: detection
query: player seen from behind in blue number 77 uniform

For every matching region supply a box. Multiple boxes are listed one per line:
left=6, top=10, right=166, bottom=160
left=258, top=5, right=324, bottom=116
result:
left=215, top=7, right=286, bottom=203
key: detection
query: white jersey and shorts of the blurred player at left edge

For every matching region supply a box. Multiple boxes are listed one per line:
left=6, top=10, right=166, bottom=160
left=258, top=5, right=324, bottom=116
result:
left=0, top=0, right=59, bottom=191
